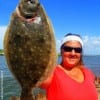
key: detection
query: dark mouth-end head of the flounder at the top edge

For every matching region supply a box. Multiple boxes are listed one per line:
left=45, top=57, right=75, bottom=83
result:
left=18, top=0, right=40, bottom=18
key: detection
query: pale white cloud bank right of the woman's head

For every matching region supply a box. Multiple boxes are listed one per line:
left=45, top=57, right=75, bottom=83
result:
left=83, top=36, right=100, bottom=55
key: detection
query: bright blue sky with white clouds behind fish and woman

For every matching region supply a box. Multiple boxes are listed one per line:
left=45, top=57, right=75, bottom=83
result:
left=0, top=0, right=100, bottom=55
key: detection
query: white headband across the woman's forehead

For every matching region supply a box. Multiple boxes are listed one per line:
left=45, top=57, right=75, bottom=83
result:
left=61, top=35, right=83, bottom=47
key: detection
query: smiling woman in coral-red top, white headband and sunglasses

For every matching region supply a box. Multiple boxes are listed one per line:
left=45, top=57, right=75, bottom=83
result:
left=41, top=34, right=98, bottom=100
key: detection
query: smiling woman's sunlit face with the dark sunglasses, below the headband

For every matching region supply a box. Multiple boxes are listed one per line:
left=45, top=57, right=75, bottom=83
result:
left=61, top=41, right=82, bottom=68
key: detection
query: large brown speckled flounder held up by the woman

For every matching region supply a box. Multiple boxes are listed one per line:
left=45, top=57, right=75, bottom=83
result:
left=4, top=0, right=56, bottom=100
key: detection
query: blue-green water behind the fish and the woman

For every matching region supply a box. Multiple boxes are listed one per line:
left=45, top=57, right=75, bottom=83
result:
left=0, top=56, right=100, bottom=100
